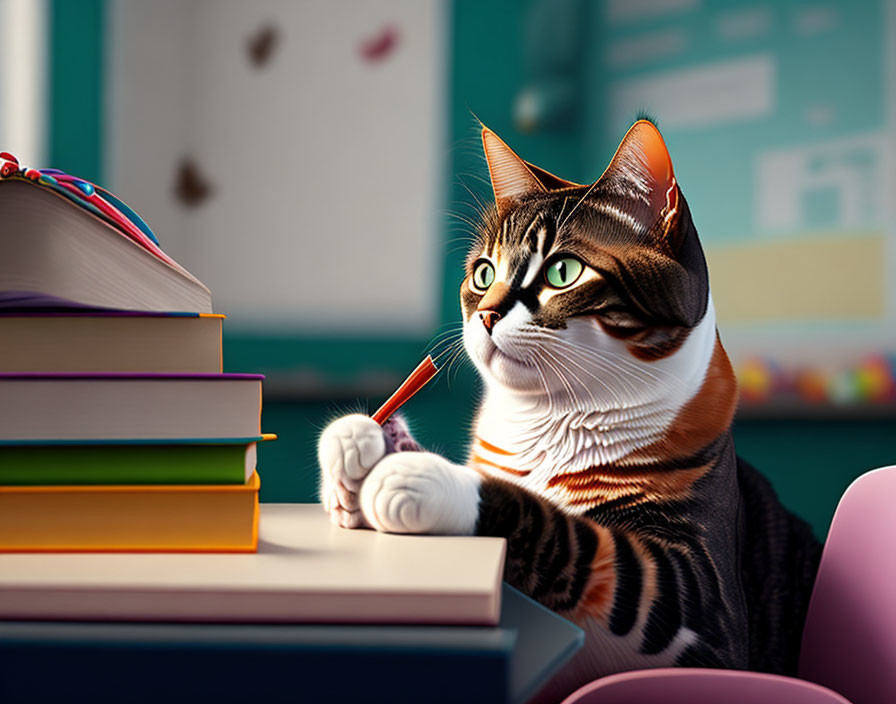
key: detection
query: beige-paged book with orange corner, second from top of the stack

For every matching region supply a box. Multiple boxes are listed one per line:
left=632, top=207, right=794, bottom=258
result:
left=0, top=307, right=224, bottom=373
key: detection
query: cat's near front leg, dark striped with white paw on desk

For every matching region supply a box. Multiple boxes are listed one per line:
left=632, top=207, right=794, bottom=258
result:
left=352, top=452, right=733, bottom=681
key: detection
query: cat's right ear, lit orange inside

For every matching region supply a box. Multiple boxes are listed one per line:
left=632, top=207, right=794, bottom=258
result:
left=601, top=120, right=680, bottom=249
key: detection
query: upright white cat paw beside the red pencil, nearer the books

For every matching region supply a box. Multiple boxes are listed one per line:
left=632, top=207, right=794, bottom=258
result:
left=317, top=414, right=386, bottom=528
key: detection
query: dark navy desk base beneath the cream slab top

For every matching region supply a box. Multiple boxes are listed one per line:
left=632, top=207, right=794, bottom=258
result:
left=0, top=585, right=584, bottom=704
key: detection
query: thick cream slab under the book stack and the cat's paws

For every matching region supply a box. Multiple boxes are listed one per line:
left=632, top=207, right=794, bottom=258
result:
left=0, top=504, right=505, bottom=626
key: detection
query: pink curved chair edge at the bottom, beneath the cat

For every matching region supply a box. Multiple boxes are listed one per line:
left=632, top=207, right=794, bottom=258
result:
left=563, top=667, right=850, bottom=704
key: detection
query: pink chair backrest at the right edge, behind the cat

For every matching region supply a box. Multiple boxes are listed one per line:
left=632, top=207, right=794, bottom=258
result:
left=799, top=466, right=896, bottom=704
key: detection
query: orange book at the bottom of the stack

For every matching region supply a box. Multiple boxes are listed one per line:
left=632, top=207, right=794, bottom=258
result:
left=0, top=473, right=260, bottom=552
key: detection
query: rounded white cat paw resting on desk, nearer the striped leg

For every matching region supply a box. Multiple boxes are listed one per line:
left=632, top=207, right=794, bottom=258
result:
left=361, top=452, right=480, bottom=535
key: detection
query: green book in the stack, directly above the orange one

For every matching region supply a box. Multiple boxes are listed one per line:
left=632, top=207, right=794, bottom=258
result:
left=0, top=435, right=277, bottom=486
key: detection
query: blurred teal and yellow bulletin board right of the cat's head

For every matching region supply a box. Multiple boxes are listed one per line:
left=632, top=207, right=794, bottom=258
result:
left=589, top=0, right=896, bottom=402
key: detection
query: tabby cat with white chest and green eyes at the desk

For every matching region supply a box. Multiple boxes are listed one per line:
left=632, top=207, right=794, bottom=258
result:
left=319, top=119, right=820, bottom=700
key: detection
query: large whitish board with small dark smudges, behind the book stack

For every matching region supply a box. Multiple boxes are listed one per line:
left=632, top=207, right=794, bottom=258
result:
left=107, top=0, right=447, bottom=336
